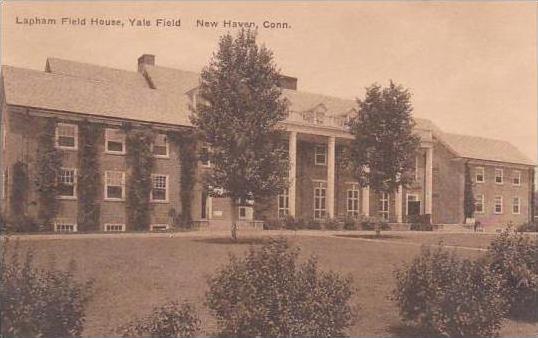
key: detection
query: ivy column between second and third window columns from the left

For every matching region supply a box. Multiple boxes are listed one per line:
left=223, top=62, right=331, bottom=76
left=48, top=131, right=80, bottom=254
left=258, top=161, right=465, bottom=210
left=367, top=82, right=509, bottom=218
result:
left=125, top=124, right=155, bottom=230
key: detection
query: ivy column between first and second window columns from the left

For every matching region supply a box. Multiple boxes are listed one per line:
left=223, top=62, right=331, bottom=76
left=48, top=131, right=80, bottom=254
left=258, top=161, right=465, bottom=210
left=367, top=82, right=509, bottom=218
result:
left=77, top=121, right=102, bottom=231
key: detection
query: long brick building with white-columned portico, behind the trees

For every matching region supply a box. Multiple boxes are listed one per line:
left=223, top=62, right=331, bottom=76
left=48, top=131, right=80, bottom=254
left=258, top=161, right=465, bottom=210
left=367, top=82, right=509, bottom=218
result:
left=0, top=55, right=534, bottom=231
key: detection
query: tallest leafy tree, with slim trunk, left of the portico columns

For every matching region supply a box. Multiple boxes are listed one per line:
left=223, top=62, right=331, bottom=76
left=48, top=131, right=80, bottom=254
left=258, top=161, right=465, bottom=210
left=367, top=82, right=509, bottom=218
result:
left=192, top=30, right=288, bottom=239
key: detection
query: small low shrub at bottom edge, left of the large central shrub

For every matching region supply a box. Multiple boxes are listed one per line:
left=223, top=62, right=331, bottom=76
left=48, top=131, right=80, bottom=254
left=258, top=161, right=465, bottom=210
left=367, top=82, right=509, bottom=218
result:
left=120, top=302, right=200, bottom=337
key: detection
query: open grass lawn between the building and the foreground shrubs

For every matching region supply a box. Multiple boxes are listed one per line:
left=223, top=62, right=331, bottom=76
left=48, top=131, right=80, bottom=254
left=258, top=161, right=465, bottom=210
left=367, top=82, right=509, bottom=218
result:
left=8, top=232, right=538, bottom=336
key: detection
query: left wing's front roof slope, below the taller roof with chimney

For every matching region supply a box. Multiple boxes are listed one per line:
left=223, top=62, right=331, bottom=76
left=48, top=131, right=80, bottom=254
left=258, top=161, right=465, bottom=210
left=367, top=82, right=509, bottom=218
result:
left=2, top=66, right=191, bottom=126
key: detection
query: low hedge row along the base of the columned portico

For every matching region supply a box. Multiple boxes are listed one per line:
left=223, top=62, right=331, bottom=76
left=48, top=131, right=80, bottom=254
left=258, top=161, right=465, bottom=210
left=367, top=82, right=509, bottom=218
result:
left=264, top=216, right=390, bottom=230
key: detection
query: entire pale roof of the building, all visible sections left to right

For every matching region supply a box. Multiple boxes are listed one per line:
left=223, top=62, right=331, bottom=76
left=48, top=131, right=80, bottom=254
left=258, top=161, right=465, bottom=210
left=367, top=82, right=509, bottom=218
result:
left=2, top=58, right=534, bottom=165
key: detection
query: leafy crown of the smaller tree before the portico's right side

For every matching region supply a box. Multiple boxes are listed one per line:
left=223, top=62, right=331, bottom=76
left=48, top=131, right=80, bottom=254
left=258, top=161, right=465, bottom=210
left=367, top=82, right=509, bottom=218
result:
left=349, top=81, right=420, bottom=198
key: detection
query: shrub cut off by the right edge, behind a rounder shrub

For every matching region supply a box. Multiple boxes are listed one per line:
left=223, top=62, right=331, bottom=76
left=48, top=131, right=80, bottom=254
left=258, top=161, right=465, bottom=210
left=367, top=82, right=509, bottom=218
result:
left=486, top=227, right=538, bottom=319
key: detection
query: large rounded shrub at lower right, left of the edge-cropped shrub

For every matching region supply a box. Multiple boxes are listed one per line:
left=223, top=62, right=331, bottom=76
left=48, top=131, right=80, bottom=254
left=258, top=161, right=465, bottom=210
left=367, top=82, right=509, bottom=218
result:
left=393, top=247, right=506, bottom=337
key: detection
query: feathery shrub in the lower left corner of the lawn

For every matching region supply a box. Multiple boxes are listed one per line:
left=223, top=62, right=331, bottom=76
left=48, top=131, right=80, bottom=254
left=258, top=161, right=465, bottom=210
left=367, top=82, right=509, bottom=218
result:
left=0, top=240, right=91, bottom=337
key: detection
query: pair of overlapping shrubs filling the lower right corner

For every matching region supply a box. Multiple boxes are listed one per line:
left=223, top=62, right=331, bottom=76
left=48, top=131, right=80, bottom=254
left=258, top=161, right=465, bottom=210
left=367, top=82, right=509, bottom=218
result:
left=393, top=228, right=538, bottom=337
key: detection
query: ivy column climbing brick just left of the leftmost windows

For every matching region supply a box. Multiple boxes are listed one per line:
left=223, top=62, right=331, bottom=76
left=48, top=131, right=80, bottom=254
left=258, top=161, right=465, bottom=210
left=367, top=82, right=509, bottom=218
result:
left=35, top=119, right=63, bottom=230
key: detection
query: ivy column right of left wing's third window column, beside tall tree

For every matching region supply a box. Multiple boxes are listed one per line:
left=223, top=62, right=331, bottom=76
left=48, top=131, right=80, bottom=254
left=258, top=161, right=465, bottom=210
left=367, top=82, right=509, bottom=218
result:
left=169, top=131, right=197, bottom=228
